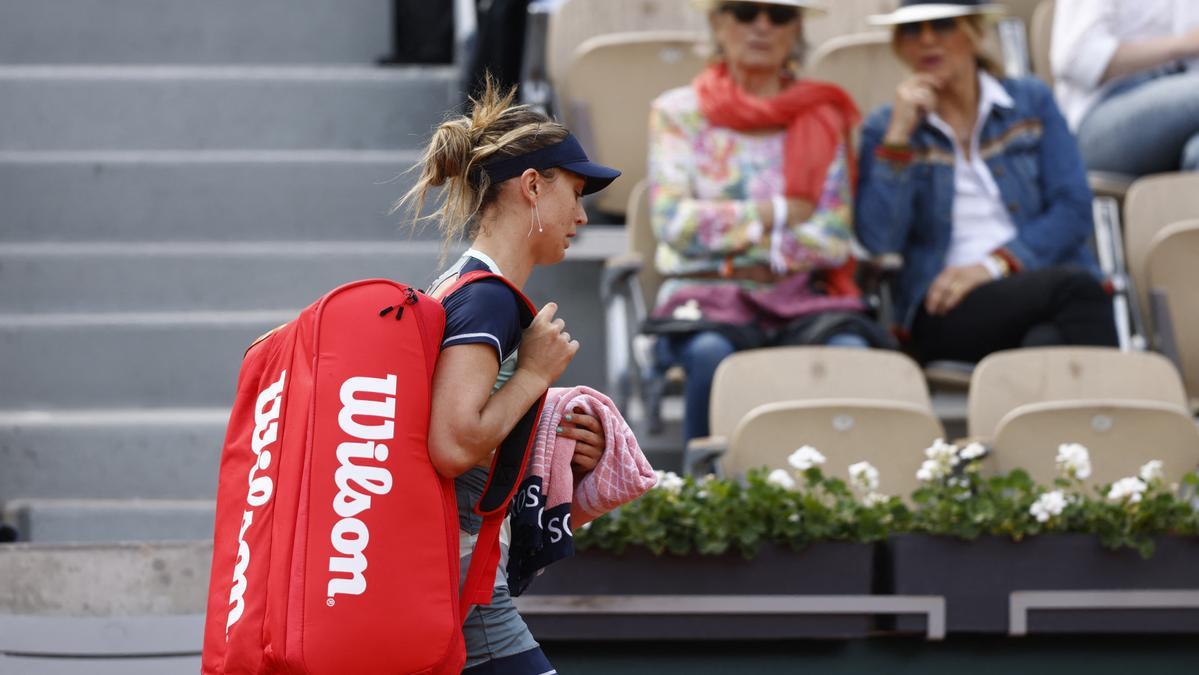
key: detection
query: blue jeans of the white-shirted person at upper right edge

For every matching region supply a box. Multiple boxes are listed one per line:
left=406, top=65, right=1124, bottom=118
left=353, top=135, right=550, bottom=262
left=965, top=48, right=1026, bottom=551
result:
left=1078, top=72, right=1199, bottom=176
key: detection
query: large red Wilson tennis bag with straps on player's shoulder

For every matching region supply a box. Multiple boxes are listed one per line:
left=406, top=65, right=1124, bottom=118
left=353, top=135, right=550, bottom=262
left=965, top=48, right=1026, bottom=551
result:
left=201, top=272, right=544, bottom=675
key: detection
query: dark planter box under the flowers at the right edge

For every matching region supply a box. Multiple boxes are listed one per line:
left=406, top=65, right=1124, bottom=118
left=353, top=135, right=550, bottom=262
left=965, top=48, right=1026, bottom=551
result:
left=885, top=535, right=1199, bottom=633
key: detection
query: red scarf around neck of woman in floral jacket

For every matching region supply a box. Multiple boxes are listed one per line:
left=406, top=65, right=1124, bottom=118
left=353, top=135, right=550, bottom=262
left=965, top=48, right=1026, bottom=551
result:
left=694, top=64, right=861, bottom=296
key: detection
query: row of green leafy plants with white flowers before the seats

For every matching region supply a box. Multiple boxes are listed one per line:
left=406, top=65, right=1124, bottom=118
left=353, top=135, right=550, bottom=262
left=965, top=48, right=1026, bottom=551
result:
left=576, top=441, right=1199, bottom=558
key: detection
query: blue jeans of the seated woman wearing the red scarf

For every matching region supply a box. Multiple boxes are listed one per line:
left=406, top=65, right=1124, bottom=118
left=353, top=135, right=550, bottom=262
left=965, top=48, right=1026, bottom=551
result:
left=657, top=331, right=870, bottom=442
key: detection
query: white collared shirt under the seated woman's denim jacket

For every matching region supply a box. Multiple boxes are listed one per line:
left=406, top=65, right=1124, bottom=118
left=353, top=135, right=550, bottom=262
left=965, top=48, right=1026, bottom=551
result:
left=928, top=71, right=1016, bottom=278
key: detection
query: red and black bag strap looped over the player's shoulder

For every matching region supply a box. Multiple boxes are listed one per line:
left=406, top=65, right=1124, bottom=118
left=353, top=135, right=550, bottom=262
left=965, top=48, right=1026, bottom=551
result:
left=440, top=270, right=546, bottom=621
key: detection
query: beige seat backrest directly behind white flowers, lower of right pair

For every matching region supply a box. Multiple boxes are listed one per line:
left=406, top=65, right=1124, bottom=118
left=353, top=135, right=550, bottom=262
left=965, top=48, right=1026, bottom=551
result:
left=988, top=400, right=1199, bottom=486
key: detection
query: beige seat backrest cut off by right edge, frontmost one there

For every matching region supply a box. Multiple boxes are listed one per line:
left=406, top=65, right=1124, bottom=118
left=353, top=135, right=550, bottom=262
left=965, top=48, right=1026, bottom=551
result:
left=1145, top=219, right=1199, bottom=409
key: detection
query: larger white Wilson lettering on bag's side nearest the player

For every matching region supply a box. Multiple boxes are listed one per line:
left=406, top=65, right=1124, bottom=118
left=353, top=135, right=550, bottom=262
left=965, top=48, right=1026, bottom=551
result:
left=327, top=375, right=396, bottom=601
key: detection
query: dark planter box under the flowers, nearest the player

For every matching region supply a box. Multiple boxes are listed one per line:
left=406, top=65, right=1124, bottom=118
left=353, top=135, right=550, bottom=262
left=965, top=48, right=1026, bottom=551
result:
left=525, top=543, right=874, bottom=640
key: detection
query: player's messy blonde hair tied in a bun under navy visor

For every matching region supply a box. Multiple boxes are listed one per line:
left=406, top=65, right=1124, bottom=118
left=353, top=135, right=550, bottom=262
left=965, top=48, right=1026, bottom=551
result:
left=392, top=76, right=570, bottom=249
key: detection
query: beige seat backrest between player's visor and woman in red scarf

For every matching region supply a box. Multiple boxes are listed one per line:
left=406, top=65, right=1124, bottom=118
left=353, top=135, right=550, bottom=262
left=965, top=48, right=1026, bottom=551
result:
left=559, top=31, right=707, bottom=213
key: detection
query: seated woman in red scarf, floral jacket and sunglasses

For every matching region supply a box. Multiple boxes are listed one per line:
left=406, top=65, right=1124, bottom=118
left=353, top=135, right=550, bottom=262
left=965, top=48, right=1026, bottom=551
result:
left=649, top=0, right=890, bottom=440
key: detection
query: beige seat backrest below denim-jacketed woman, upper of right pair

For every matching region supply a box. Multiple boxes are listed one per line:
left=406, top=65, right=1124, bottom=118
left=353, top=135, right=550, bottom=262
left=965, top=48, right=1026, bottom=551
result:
left=966, top=346, right=1186, bottom=438
